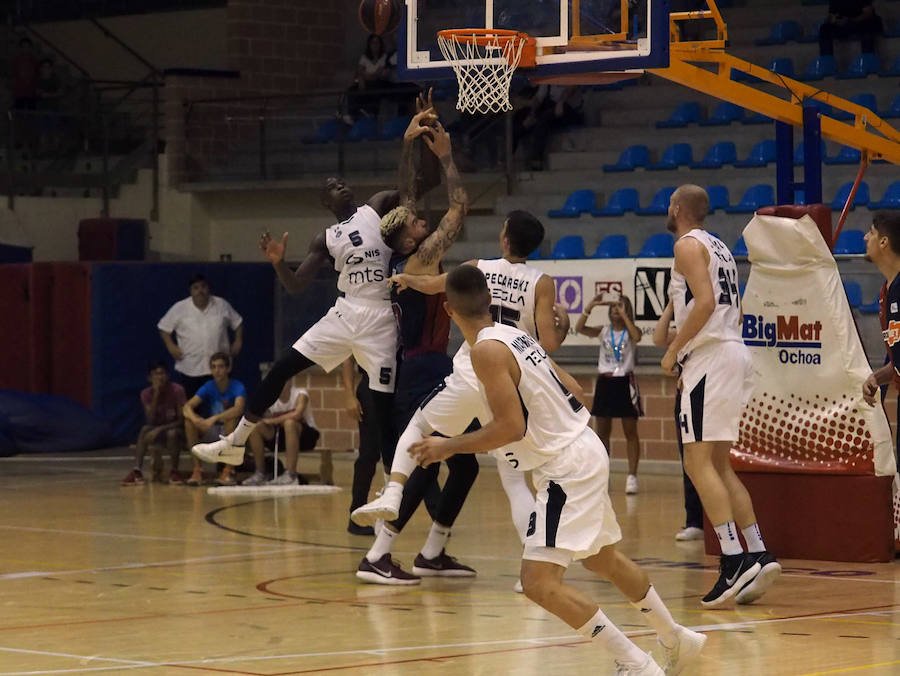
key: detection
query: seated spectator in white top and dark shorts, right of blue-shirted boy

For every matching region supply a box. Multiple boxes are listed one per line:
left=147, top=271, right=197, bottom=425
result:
left=241, top=378, right=322, bottom=486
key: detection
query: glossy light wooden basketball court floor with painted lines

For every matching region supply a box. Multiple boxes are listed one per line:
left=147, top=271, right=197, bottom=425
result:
left=0, top=449, right=900, bottom=676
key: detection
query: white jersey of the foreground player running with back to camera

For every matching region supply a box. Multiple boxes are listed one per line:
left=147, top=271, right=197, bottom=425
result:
left=475, top=324, right=590, bottom=472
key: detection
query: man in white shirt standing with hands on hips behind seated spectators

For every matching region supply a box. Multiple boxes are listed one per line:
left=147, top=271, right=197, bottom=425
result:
left=156, top=274, right=244, bottom=399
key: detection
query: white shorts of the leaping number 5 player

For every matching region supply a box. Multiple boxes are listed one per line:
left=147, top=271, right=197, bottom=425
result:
left=294, top=297, right=398, bottom=392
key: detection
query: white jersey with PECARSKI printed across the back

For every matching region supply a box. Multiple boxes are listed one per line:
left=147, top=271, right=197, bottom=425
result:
left=476, top=258, right=544, bottom=338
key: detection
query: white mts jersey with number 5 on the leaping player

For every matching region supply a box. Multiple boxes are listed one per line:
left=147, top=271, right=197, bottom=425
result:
left=325, top=204, right=393, bottom=303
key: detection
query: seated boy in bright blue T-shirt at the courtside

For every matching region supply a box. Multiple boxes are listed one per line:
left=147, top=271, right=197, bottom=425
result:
left=183, top=352, right=247, bottom=486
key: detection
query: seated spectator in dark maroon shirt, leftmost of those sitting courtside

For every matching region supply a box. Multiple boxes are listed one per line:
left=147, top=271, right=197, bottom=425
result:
left=122, top=361, right=185, bottom=486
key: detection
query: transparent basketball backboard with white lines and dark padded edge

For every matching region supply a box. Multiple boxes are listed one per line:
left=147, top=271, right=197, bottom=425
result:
left=397, top=0, right=669, bottom=80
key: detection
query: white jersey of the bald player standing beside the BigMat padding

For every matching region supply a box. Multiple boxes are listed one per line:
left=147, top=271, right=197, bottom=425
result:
left=669, top=228, right=743, bottom=362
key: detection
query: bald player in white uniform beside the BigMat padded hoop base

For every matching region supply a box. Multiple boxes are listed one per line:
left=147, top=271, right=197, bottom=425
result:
left=661, top=185, right=781, bottom=607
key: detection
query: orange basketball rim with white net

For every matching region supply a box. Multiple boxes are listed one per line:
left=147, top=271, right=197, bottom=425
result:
left=438, top=28, right=536, bottom=113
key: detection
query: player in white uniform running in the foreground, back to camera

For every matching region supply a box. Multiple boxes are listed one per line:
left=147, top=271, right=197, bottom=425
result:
left=410, top=265, right=706, bottom=676
